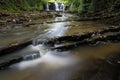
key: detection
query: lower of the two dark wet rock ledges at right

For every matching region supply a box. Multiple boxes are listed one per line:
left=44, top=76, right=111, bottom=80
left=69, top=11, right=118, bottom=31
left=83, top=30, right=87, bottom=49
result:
left=51, top=33, right=120, bottom=51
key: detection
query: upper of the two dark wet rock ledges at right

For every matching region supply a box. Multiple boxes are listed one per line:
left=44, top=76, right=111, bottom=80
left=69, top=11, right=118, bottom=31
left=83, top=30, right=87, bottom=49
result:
left=45, top=27, right=120, bottom=46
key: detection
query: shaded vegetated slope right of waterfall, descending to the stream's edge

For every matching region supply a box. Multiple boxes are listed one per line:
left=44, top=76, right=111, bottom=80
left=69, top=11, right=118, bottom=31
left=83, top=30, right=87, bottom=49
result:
left=68, top=0, right=120, bottom=25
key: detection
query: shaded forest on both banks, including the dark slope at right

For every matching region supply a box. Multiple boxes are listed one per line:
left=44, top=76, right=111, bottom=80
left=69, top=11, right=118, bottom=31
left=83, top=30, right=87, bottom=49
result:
left=0, top=0, right=120, bottom=25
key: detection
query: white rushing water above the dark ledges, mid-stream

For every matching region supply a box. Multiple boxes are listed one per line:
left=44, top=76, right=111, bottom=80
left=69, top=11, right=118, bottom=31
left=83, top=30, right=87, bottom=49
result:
left=33, top=16, right=69, bottom=43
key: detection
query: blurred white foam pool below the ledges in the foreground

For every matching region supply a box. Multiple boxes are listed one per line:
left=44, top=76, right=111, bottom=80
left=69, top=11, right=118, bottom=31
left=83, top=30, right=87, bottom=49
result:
left=11, top=51, right=77, bottom=70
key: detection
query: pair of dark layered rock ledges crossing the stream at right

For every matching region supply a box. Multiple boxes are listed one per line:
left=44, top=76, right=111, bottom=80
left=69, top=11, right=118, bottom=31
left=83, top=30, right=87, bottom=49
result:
left=44, top=27, right=120, bottom=51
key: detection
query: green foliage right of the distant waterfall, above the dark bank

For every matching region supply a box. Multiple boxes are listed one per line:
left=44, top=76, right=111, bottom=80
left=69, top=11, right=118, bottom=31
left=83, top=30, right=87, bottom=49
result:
left=68, top=0, right=120, bottom=13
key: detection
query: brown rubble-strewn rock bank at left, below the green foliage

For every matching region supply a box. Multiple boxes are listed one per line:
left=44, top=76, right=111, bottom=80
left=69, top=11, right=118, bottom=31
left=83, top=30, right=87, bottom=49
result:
left=0, top=11, right=54, bottom=25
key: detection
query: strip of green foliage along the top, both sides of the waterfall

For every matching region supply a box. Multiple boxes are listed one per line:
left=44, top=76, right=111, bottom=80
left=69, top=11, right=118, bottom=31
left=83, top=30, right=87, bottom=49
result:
left=0, top=0, right=120, bottom=13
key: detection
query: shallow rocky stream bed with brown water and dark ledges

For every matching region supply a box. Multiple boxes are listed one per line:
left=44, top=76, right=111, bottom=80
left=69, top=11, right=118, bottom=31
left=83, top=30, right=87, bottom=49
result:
left=0, top=12, right=120, bottom=80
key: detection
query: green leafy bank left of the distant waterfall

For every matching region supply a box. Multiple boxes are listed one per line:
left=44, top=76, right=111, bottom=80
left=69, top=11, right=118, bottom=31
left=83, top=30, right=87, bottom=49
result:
left=0, top=0, right=45, bottom=11
